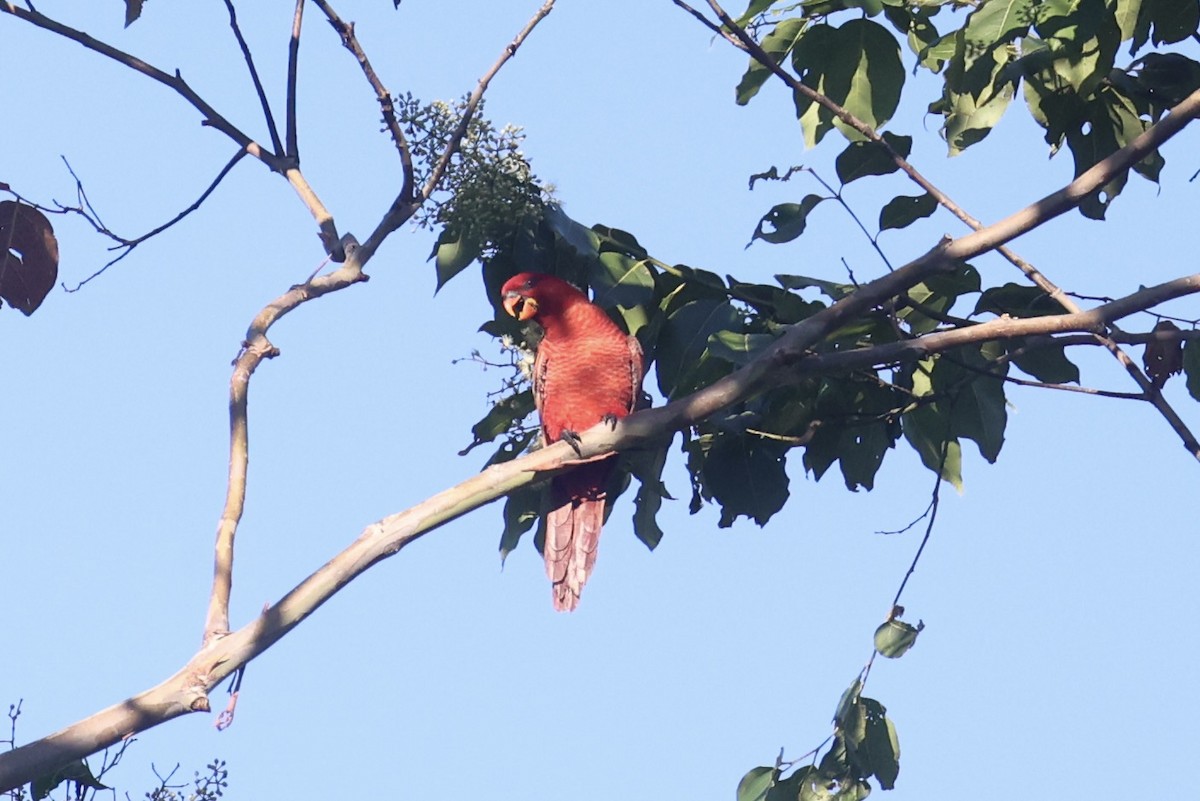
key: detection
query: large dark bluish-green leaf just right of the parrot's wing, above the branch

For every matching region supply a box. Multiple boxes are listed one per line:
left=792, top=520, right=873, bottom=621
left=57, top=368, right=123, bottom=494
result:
left=654, top=299, right=742, bottom=399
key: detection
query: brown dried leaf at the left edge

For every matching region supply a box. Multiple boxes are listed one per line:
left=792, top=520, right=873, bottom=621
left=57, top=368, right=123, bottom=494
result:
left=0, top=200, right=59, bottom=317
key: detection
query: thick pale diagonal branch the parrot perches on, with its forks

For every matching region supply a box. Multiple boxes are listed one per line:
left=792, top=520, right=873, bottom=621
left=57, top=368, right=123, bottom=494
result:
left=0, top=103, right=1200, bottom=791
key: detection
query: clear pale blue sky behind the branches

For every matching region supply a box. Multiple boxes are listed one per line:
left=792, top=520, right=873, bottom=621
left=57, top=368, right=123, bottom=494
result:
left=0, top=0, right=1200, bottom=801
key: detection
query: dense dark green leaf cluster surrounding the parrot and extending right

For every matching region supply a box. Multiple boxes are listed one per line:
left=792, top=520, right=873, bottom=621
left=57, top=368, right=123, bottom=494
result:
left=444, top=196, right=1078, bottom=554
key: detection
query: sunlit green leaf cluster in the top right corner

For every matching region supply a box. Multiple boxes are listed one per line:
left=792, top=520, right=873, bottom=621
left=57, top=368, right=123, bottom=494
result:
left=737, top=0, right=1200, bottom=218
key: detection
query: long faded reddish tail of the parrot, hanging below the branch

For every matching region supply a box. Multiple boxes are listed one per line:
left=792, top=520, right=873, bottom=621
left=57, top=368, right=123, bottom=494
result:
left=544, top=459, right=616, bottom=612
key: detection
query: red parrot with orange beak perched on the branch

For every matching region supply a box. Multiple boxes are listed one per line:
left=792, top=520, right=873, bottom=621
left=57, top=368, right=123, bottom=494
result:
left=500, top=272, right=642, bottom=612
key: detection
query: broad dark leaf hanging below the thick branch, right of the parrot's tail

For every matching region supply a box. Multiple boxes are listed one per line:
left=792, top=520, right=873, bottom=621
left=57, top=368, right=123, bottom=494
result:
left=703, top=434, right=788, bottom=529
